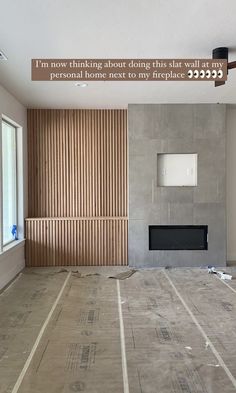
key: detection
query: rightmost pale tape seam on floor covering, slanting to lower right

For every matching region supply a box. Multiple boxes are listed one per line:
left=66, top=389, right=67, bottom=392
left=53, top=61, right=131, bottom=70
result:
left=163, top=271, right=236, bottom=389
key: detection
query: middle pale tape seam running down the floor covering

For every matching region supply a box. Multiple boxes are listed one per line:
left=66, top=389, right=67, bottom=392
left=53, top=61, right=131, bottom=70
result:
left=116, top=280, right=129, bottom=393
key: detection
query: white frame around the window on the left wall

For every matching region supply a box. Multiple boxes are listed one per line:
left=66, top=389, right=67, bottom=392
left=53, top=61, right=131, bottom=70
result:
left=0, top=115, right=22, bottom=254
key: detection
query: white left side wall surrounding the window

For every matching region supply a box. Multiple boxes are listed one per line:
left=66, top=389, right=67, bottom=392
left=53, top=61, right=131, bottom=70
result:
left=0, top=85, right=28, bottom=289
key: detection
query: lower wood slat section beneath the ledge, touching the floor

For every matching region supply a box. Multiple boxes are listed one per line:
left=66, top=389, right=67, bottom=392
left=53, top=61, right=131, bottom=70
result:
left=26, top=218, right=128, bottom=267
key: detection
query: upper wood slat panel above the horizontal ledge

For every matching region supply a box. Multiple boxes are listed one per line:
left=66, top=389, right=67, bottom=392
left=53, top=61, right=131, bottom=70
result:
left=28, top=109, right=127, bottom=218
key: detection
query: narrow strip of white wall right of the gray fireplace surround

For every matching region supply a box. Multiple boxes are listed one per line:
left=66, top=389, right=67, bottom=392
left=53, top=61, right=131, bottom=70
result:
left=226, top=105, right=236, bottom=261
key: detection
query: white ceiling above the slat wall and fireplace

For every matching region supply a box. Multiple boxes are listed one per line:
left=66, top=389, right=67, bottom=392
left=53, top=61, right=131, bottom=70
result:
left=0, top=0, right=236, bottom=108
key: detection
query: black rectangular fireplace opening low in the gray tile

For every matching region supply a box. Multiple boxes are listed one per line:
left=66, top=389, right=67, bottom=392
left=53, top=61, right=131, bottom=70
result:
left=149, top=225, right=208, bottom=250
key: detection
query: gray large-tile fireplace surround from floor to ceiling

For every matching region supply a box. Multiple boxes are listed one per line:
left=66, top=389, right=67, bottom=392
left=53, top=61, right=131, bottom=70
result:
left=128, top=104, right=226, bottom=267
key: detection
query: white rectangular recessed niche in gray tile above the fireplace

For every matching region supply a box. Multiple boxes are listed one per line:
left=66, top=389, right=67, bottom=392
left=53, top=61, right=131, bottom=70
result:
left=157, top=153, right=197, bottom=187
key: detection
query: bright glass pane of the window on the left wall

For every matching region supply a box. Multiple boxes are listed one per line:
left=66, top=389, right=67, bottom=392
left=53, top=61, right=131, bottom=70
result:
left=1, top=120, right=17, bottom=246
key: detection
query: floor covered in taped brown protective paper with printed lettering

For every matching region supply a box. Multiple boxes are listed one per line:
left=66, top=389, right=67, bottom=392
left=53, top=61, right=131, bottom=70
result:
left=0, top=267, right=236, bottom=393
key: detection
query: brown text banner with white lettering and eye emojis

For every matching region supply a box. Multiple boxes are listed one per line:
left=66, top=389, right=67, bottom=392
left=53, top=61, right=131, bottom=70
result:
left=32, top=59, right=227, bottom=81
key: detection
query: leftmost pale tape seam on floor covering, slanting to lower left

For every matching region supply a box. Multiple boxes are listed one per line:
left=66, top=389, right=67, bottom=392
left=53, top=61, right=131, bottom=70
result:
left=12, top=272, right=71, bottom=393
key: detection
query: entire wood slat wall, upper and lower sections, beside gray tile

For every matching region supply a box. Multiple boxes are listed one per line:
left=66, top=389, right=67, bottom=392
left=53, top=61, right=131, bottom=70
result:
left=26, top=109, right=128, bottom=266
